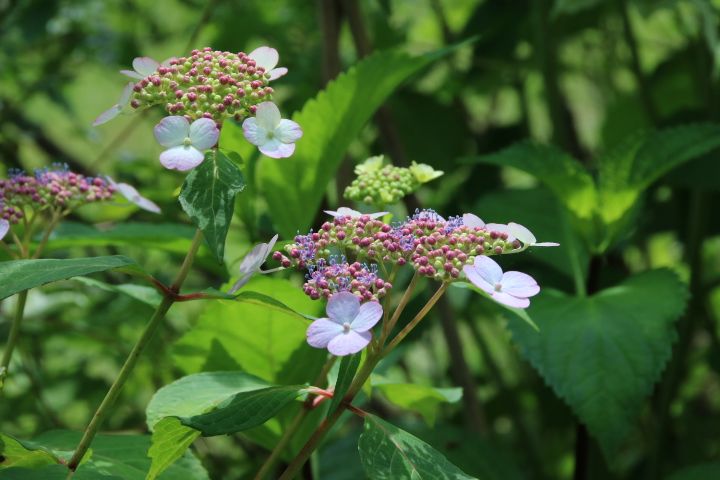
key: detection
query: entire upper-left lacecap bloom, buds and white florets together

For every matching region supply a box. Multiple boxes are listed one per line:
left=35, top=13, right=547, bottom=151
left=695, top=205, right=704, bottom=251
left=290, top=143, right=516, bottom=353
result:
left=95, top=47, right=302, bottom=171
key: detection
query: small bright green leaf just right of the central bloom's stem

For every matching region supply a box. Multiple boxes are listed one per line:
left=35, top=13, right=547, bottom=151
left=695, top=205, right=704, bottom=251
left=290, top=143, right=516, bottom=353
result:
left=373, top=378, right=462, bottom=426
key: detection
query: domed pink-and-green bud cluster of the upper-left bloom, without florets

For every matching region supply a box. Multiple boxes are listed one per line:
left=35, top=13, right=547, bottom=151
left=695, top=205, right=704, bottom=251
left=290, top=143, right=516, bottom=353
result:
left=130, top=47, right=273, bottom=124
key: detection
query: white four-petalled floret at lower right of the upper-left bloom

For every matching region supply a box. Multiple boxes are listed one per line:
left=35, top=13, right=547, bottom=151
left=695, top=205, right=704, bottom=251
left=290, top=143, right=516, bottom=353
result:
left=243, top=102, right=303, bottom=158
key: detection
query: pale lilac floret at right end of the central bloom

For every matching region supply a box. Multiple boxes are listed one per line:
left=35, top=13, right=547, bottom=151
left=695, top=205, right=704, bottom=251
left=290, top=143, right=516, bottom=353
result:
left=463, top=256, right=540, bottom=308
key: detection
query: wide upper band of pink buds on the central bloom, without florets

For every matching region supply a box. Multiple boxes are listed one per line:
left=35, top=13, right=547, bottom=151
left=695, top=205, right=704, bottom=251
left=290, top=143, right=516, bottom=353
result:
left=274, top=210, right=523, bottom=281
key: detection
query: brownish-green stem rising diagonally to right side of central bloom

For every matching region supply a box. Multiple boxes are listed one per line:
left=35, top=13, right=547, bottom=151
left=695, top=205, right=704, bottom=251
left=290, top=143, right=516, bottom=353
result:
left=278, top=283, right=450, bottom=480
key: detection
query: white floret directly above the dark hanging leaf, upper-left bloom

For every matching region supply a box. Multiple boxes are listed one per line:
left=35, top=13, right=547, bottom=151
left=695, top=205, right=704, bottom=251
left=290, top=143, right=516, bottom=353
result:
left=154, top=116, right=220, bottom=172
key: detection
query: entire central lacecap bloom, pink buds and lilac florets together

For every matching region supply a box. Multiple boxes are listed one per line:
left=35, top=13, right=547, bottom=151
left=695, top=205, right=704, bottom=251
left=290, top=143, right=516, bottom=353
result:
left=273, top=207, right=556, bottom=355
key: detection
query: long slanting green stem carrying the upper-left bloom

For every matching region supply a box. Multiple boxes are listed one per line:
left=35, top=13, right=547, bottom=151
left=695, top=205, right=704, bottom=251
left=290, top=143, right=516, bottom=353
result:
left=68, top=229, right=202, bottom=472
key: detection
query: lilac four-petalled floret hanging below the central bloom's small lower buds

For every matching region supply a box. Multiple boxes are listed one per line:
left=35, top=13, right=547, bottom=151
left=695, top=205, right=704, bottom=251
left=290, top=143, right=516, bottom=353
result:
left=307, top=292, right=383, bottom=356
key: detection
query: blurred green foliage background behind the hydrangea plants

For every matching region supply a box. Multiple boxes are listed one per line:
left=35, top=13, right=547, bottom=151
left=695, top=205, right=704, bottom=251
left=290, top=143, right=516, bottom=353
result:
left=0, top=0, right=720, bottom=480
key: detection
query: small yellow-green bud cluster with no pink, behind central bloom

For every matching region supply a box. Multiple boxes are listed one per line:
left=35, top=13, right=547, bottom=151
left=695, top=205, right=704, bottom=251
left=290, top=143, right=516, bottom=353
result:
left=345, top=155, right=443, bottom=207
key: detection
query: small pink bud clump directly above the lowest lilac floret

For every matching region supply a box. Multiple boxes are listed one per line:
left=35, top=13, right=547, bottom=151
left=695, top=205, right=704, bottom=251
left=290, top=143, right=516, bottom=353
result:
left=300, top=258, right=392, bottom=301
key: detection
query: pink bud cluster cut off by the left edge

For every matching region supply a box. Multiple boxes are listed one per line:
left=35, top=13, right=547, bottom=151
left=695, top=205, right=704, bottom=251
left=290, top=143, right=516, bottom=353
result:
left=0, top=165, right=115, bottom=223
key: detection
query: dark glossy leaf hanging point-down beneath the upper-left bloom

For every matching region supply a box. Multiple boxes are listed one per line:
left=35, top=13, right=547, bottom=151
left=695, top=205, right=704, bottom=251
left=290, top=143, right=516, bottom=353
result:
left=179, top=150, right=245, bottom=262
